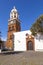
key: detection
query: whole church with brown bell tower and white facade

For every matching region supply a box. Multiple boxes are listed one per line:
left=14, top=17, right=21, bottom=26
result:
left=6, top=7, right=43, bottom=51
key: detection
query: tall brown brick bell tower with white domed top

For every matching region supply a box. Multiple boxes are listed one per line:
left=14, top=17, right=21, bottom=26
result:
left=6, top=7, right=21, bottom=50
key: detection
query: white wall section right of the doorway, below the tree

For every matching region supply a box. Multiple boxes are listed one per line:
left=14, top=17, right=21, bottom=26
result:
left=34, top=35, right=43, bottom=51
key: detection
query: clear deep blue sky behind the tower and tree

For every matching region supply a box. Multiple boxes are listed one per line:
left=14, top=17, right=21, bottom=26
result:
left=0, top=0, right=43, bottom=39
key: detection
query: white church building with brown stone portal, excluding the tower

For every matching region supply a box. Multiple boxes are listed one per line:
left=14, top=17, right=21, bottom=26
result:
left=14, top=30, right=43, bottom=51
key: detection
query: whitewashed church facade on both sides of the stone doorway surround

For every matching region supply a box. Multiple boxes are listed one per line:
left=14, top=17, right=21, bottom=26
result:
left=14, top=30, right=43, bottom=51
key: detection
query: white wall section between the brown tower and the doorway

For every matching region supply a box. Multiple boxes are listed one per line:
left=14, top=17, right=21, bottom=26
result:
left=14, top=30, right=31, bottom=51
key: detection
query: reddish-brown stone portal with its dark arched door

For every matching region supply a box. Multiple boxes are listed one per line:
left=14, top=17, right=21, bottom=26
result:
left=26, top=35, right=34, bottom=50
